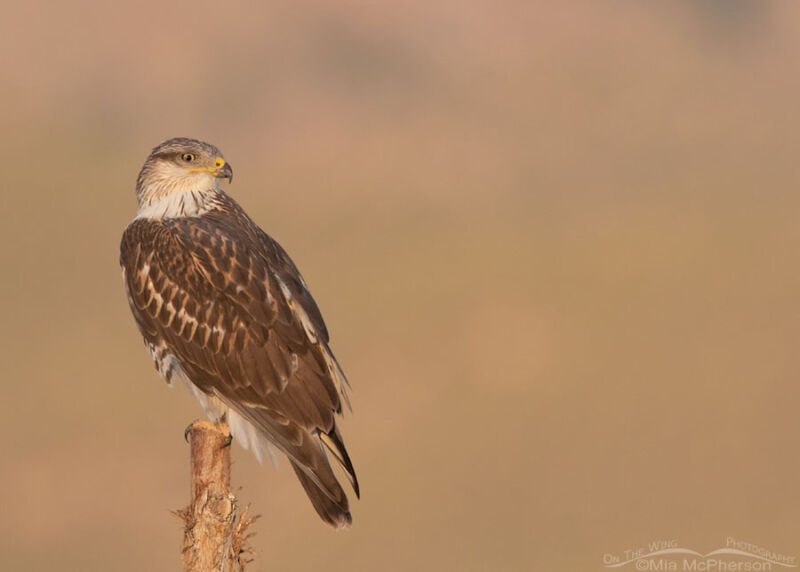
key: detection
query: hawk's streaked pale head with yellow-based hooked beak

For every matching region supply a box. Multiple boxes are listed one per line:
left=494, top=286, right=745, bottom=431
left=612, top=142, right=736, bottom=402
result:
left=136, top=137, right=233, bottom=206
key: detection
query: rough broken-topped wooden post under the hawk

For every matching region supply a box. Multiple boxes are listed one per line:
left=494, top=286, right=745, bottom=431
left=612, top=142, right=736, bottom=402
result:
left=178, top=421, right=255, bottom=572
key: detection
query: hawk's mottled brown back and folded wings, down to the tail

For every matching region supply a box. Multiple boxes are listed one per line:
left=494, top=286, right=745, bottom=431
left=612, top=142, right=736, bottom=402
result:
left=120, top=208, right=358, bottom=524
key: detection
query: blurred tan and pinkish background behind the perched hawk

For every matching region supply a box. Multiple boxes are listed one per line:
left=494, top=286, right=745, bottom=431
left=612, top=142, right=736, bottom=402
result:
left=0, top=0, right=800, bottom=571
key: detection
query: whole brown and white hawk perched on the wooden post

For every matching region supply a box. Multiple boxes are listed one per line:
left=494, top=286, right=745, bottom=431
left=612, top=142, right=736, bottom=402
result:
left=120, top=138, right=359, bottom=528
